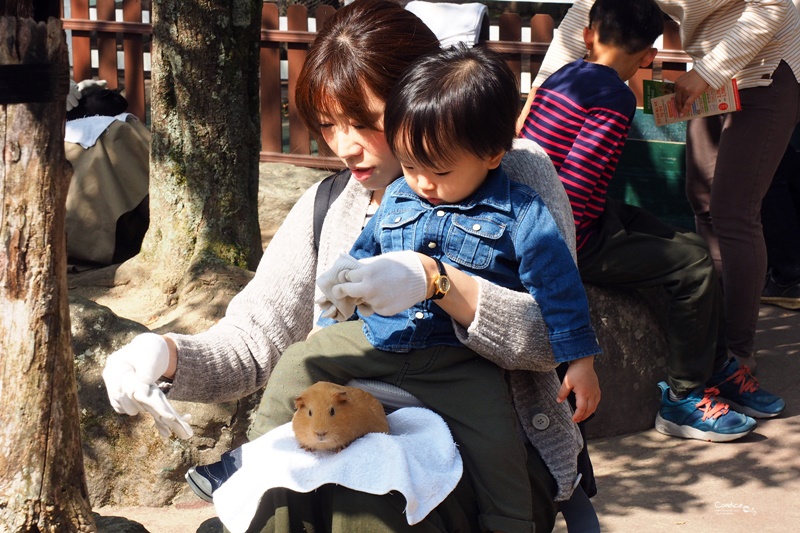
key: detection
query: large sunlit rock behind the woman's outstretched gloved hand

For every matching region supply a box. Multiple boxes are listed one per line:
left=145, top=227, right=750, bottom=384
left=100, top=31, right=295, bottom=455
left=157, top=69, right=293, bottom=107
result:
left=70, top=296, right=258, bottom=507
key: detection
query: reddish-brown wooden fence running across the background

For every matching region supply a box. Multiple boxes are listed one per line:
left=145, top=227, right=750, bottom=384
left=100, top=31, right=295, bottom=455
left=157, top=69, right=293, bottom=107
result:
left=64, top=0, right=689, bottom=168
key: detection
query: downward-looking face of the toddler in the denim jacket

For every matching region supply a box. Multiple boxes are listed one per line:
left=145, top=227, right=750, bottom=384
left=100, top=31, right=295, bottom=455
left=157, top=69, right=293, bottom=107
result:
left=400, top=151, right=503, bottom=205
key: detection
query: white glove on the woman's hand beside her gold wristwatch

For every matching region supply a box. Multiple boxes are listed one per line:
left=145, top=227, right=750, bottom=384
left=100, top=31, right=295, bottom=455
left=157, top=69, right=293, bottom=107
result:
left=333, top=250, right=428, bottom=316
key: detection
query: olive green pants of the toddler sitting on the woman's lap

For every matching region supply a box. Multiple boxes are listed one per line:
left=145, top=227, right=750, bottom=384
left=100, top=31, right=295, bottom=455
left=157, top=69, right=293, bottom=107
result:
left=248, top=321, right=552, bottom=533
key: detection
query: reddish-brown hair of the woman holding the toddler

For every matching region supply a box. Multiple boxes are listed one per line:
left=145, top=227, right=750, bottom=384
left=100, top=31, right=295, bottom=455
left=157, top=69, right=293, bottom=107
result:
left=295, top=0, right=439, bottom=139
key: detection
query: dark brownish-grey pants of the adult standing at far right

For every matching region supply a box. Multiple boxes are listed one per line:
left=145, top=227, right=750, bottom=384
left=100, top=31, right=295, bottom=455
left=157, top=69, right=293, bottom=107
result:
left=686, top=61, right=800, bottom=357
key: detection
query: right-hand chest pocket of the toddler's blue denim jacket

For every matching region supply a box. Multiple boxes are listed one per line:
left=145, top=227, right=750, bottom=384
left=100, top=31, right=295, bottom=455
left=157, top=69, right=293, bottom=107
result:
left=444, top=214, right=506, bottom=269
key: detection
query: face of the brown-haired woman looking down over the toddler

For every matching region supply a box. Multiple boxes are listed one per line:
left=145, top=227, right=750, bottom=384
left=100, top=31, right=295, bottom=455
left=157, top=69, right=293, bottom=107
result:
left=320, top=92, right=402, bottom=191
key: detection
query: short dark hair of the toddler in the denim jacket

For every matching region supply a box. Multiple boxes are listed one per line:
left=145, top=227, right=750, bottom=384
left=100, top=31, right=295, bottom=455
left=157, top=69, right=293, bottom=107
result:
left=384, top=45, right=520, bottom=168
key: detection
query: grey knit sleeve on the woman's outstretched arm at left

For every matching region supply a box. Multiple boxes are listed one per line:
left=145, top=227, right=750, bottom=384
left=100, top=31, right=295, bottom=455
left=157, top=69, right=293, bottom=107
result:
left=169, top=185, right=317, bottom=403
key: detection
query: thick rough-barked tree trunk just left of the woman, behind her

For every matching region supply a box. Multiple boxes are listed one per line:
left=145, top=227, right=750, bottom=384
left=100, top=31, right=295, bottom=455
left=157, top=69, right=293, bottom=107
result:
left=137, top=0, right=262, bottom=292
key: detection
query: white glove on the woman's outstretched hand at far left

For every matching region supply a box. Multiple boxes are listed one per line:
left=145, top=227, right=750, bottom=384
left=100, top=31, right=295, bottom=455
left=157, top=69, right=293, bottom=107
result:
left=103, top=333, right=193, bottom=439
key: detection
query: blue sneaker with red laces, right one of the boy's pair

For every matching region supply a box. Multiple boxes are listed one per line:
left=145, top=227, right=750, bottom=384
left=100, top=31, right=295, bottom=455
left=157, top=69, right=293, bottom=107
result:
left=708, top=358, right=786, bottom=418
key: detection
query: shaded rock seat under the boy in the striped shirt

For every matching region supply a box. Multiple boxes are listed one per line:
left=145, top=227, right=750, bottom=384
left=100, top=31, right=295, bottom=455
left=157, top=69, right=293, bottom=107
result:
left=586, top=285, right=668, bottom=438
